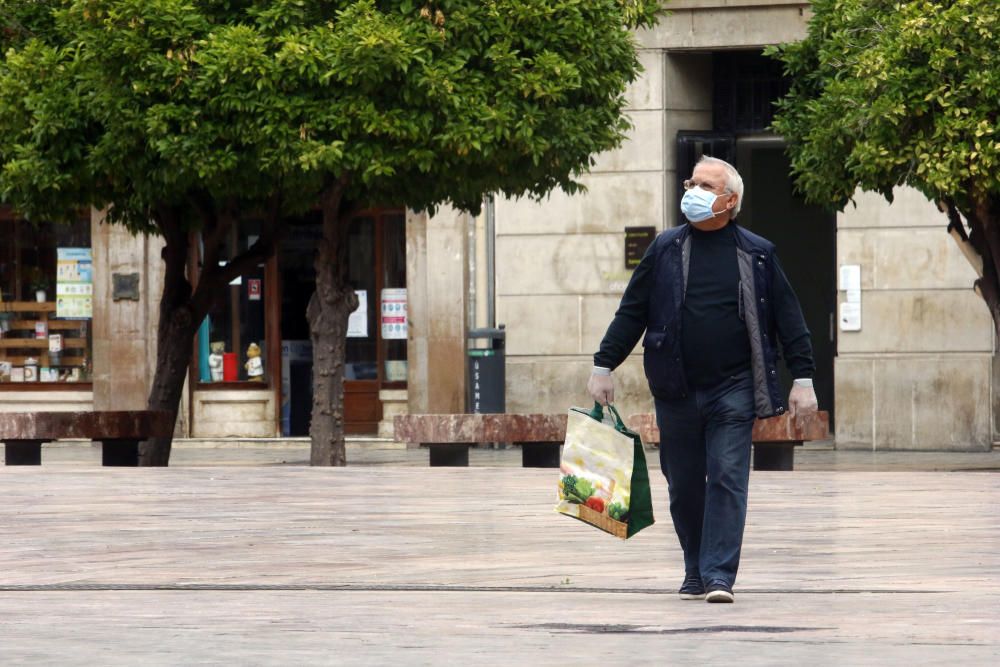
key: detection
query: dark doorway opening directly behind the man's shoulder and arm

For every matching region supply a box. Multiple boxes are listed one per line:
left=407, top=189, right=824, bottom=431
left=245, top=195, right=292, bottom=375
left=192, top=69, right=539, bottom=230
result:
left=736, top=137, right=837, bottom=428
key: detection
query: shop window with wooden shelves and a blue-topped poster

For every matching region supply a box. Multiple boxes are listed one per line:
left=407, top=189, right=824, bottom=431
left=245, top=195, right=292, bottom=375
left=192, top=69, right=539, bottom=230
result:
left=0, top=208, right=93, bottom=389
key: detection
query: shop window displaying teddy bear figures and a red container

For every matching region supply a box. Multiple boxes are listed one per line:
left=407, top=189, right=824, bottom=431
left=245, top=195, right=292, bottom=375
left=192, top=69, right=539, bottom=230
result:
left=197, top=220, right=272, bottom=386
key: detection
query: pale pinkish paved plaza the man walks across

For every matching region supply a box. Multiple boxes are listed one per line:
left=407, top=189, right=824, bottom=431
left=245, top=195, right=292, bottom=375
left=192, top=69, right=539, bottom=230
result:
left=0, top=443, right=1000, bottom=666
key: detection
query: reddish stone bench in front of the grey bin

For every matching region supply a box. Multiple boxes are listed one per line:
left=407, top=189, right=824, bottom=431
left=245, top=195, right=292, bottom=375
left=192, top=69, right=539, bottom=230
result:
left=393, top=414, right=566, bottom=468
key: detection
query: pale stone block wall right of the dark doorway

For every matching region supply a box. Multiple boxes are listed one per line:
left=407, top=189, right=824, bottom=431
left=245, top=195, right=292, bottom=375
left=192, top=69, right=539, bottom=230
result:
left=835, top=189, right=993, bottom=450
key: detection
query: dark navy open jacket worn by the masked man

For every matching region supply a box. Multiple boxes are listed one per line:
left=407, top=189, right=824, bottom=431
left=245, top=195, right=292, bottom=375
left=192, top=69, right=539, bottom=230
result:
left=594, top=223, right=815, bottom=418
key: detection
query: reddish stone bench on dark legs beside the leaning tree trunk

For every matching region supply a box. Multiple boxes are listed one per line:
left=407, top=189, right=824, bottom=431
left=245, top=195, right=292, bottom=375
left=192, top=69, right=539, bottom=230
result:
left=0, top=410, right=174, bottom=466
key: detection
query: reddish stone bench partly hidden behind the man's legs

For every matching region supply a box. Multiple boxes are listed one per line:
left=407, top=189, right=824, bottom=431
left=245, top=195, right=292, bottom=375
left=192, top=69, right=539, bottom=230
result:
left=625, top=411, right=830, bottom=470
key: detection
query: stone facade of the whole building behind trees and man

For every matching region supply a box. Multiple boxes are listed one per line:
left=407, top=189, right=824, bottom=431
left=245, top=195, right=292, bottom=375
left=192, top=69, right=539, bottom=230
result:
left=0, top=0, right=1000, bottom=450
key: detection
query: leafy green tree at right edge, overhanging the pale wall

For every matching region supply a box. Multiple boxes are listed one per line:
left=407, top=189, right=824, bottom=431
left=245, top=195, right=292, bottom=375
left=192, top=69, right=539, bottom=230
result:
left=770, top=0, right=1000, bottom=334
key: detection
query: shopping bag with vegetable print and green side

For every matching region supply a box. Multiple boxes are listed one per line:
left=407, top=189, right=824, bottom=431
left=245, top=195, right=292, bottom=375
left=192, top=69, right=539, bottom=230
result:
left=556, top=403, right=653, bottom=540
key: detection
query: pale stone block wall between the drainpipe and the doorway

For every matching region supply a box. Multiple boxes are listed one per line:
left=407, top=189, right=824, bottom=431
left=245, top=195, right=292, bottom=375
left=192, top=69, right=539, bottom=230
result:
left=496, top=49, right=668, bottom=420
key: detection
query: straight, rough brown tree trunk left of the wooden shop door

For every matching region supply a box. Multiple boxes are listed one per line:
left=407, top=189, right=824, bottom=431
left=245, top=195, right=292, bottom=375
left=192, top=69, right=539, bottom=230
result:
left=306, top=183, right=358, bottom=466
